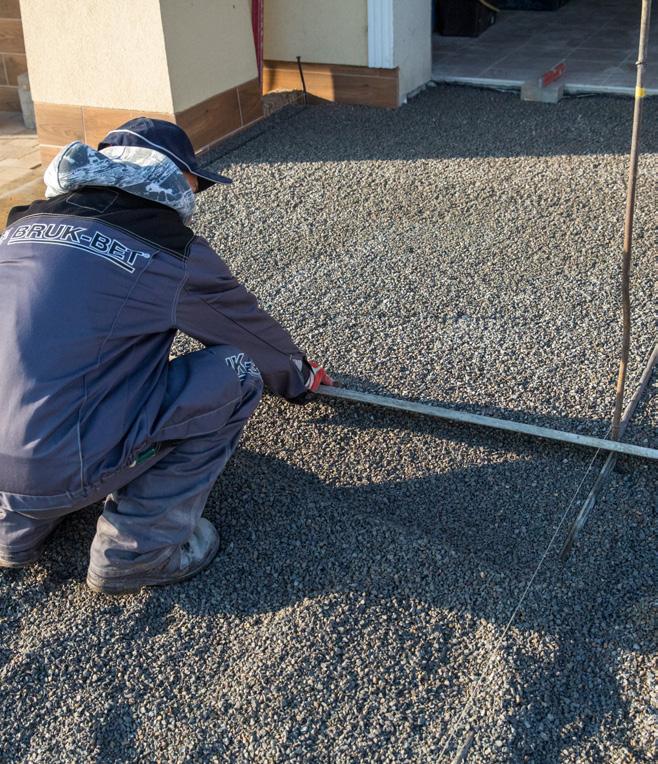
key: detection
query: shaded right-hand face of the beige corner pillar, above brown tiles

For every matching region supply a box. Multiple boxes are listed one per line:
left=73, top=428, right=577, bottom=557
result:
left=160, top=0, right=258, bottom=111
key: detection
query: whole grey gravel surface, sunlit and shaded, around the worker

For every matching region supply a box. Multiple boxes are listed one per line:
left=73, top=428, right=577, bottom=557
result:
left=0, top=87, right=658, bottom=763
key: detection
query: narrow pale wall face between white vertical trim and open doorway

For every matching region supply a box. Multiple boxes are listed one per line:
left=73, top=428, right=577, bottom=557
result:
left=393, top=0, right=432, bottom=101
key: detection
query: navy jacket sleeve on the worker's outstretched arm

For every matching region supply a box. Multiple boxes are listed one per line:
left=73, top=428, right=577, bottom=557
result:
left=175, top=236, right=306, bottom=400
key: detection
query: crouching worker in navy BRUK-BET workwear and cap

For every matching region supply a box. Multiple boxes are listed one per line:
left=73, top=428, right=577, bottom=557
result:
left=0, top=118, right=331, bottom=593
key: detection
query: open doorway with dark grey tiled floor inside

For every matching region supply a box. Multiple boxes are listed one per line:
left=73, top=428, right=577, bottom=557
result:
left=432, top=0, right=658, bottom=95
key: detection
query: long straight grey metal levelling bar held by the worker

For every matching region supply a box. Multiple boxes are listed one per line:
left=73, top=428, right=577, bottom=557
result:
left=318, top=385, right=658, bottom=460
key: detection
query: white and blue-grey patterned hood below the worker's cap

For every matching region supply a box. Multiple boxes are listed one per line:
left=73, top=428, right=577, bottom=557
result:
left=43, top=141, right=195, bottom=224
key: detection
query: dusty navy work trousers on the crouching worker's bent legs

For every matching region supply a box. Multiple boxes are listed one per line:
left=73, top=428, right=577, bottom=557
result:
left=0, top=345, right=263, bottom=575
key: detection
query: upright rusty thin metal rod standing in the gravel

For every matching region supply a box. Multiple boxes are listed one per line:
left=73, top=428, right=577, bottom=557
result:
left=611, top=0, right=652, bottom=440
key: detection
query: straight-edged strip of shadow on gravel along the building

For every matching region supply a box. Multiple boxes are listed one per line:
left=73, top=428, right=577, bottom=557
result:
left=204, top=85, right=658, bottom=166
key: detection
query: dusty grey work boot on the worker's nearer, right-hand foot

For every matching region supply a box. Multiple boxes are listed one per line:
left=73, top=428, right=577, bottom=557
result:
left=87, top=517, right=219, bottom=594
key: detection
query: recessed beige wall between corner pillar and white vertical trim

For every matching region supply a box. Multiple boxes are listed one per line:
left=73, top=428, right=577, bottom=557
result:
left=264, top=0, right=368, bottom=66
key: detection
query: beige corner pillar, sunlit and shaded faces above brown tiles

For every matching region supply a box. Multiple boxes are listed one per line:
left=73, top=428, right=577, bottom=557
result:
left=22, top=0, right=258, bottom=112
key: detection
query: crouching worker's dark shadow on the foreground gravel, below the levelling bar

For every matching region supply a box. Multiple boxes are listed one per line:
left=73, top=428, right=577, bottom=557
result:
left=200, top=444, right=651, bottom=760
